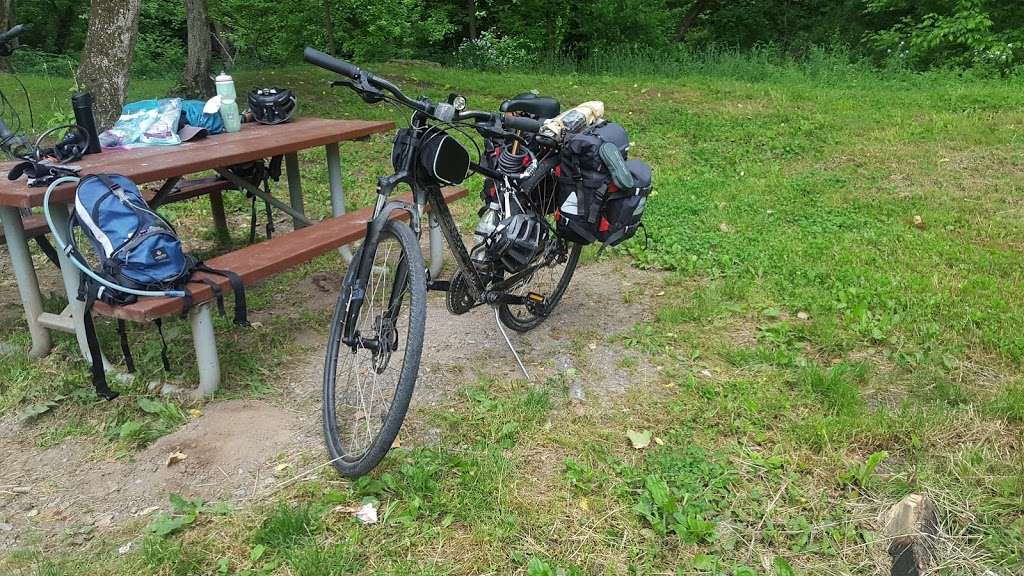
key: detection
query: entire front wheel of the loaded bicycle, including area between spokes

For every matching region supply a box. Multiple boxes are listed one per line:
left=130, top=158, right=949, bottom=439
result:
left=324, top=220, right=427, bottom=478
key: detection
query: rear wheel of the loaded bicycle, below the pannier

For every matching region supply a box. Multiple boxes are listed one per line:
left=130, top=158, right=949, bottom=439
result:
left=498, top=238, right=582, bottom=332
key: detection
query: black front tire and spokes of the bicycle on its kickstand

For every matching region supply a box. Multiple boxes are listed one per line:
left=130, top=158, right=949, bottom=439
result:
left=323, top=220, right=427, bottom=478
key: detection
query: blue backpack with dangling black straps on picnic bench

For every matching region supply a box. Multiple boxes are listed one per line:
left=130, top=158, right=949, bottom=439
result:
left=67, top=174, right=248, bottom=400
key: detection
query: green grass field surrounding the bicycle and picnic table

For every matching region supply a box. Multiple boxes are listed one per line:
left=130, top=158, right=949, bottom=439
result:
left=0, top=57, right=1024, bottom=576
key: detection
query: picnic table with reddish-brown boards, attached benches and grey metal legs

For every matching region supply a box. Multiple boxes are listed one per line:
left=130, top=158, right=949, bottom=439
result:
left=0, top=118, right=465, bottom=396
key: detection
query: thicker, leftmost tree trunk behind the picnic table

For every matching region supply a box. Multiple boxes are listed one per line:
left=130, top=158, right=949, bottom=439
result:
left=78, top=0, right=141, bottom=130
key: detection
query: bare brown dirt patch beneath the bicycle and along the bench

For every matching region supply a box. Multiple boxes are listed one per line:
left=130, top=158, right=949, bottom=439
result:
left=0, top=259, right=662, bottom=551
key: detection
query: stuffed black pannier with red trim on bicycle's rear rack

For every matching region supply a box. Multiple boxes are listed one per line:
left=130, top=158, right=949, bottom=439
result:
left=555, top=122, right=651, bottom=246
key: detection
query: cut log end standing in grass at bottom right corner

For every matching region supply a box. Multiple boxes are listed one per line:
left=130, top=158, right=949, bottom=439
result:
left=881, top=494, right=940, bottom=576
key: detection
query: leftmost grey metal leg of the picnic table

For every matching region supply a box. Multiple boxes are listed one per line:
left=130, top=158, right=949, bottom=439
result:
left=0, top=206, right=50, bottom=358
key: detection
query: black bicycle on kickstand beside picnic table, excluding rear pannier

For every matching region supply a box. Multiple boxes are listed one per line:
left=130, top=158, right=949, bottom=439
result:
left=304, top=48, right=581, bottom=477
